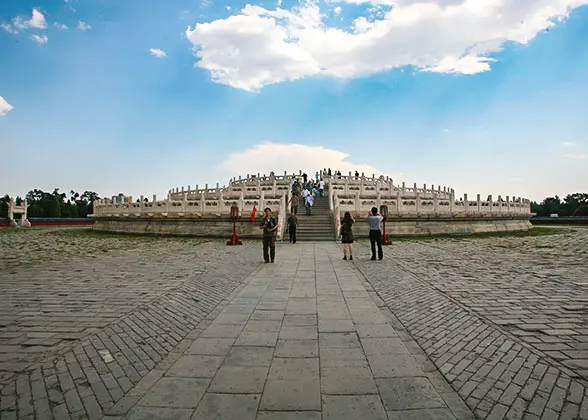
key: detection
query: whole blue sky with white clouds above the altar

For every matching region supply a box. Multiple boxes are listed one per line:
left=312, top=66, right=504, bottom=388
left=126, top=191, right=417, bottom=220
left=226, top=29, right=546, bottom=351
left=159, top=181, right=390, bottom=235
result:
left=0, top=0, right=588, bottom=200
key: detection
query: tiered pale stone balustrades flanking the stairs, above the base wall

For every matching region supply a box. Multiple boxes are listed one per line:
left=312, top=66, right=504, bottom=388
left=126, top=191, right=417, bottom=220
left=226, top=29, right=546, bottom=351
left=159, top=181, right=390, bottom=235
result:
left=93, top=171, right=531, bottom=217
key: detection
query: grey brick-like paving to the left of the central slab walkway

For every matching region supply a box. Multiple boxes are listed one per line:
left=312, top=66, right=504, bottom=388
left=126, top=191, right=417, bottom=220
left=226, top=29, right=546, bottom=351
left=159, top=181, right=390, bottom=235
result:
left=0, top=231, right=259, bottom=420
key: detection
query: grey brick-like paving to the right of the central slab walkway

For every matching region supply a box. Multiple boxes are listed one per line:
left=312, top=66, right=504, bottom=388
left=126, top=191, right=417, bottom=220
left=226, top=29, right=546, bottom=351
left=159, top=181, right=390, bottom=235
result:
left=355, top=229, right=588, bottom=419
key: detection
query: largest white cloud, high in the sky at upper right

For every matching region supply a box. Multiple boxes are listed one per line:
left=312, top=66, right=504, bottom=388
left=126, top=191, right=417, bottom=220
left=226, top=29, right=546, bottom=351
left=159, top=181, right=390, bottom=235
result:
left=186, top=0, right=588, bottom=91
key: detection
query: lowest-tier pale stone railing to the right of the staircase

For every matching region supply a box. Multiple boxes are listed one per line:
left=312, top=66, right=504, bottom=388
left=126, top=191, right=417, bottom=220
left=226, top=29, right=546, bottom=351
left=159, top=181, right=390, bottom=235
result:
left=329, top=190, right=531, bottom=218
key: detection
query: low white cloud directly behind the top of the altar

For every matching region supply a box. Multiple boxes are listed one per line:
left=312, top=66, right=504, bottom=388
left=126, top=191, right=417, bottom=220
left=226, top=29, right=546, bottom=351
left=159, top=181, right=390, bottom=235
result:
left=219, top=142, right=402, bottom=180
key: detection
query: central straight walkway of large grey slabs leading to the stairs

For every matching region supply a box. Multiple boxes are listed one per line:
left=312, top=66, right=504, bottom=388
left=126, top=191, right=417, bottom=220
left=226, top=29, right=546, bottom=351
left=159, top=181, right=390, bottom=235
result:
left=104, top=243, right=474, bottom=420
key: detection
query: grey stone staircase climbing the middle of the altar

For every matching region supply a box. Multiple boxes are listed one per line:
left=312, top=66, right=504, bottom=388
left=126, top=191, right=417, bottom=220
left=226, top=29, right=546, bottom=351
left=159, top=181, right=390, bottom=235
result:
left=284, top=190, right=335, bottom=242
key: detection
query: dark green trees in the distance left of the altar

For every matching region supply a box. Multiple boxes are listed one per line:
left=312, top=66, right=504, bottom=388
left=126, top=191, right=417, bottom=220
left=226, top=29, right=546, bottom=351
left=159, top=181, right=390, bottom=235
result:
left=0, top=188, right=100, bottom=217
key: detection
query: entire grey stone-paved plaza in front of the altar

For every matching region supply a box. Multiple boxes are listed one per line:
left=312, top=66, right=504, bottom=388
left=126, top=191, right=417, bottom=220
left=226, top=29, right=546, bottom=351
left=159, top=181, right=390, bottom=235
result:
left=0, top=230, right=588, bottom=420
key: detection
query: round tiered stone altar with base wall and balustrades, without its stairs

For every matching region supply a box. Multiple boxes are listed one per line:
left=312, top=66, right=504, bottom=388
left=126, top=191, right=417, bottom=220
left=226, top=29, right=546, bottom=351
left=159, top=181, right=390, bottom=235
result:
left=92, top=172, right=532, bottom=240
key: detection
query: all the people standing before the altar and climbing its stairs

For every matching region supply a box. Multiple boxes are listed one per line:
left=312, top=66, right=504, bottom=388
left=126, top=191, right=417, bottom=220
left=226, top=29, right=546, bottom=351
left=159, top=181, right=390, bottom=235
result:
left=259, top=168, right=384, bottom=263
